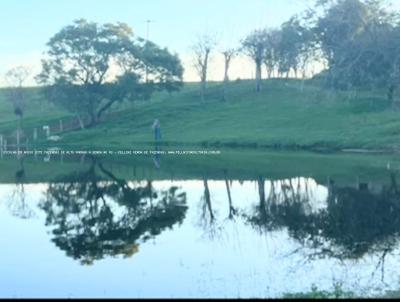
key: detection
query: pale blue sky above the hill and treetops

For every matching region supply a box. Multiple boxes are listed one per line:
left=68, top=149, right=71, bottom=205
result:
left=0, top=0, right=400, bottom=85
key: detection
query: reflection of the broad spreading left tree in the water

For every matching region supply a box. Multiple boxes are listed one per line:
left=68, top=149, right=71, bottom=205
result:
left=40, top=159, right=187, bottom=264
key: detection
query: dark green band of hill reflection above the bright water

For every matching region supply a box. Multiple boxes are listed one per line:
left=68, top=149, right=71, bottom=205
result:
left=0, top=149, right=400, bottom=186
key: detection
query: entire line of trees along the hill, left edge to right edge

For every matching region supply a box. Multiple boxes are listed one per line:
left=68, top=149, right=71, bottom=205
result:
left=2, top=0, right=400, bottom=129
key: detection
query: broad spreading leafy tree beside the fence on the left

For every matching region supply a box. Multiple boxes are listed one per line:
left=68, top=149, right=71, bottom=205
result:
left=37, top=19, right=183, bottom=125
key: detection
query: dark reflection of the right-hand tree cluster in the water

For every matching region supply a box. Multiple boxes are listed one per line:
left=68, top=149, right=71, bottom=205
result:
left=246, top=174, right=400, bottom=261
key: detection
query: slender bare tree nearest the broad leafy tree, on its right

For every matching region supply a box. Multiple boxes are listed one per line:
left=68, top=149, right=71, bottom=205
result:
left=193, top=34, right=216, bottom=102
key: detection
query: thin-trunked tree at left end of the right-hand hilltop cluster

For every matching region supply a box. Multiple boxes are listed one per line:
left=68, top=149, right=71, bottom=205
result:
left=242, top=30, right=266, bottom=92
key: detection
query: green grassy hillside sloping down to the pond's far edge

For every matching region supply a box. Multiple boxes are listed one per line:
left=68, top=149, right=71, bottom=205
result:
left=0, top=80, right=400, bottom=150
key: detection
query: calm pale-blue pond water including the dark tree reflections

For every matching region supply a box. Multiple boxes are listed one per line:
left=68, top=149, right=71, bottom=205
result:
left=0, top=156, right=400, bottom=298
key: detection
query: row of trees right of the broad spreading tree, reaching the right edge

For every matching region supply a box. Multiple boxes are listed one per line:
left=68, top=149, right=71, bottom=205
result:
left=195, top=0, right=400, bottom=101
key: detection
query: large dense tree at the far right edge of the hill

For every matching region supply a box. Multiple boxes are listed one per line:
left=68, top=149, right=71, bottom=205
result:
left=315, top=0, right=400, bottom=101
